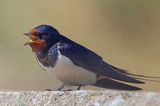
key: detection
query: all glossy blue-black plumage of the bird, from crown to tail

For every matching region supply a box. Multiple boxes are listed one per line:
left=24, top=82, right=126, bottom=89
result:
left=25, top=25, right=149, bottom=90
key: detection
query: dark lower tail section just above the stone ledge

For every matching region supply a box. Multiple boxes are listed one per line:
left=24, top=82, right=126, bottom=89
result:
left=94, top=78, right=142, bottom=91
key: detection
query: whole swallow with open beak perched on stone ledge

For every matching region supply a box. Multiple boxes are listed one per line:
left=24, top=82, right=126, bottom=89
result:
left=24, top=24, right=160, bottom=91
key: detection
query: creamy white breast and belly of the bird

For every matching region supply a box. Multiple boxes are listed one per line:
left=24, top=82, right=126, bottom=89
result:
left=36, top=53, right=97, bottom=86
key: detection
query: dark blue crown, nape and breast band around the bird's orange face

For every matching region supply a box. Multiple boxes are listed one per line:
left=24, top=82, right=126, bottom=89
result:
left=34, top=25, right=61, bottom=67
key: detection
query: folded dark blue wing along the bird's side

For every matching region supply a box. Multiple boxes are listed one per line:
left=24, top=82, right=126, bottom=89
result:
left=59, top=38, right=144, bottom=84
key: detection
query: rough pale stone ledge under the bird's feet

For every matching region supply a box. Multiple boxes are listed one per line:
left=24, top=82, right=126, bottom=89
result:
left=0, top=90, right=160, bottom=106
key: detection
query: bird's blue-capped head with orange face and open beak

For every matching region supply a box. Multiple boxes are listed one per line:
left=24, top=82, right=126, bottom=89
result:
left=25, top=25, right=61, bottom=52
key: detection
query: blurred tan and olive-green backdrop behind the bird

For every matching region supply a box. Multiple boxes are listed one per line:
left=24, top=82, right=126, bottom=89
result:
left=0, top=0, right=160, bottom=91
